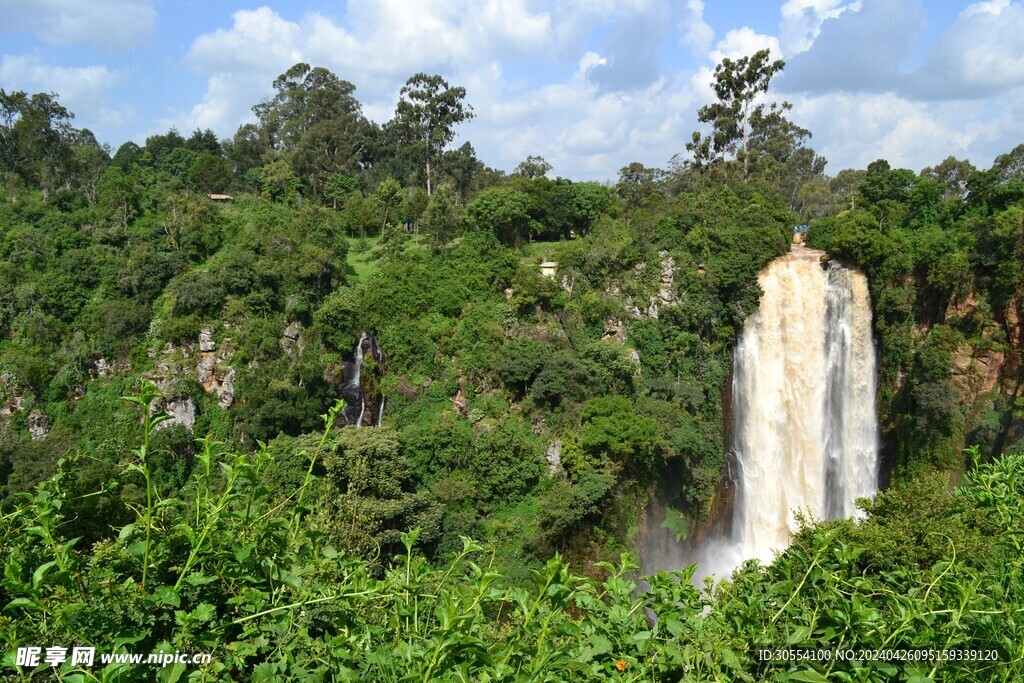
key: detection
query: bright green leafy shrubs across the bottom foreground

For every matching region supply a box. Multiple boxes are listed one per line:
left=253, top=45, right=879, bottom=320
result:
left=0, top=390, right=1024, bottom=681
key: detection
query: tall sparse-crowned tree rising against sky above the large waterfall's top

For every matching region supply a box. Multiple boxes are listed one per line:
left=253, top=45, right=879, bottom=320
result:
left=686, top=50, right=787, bottom=178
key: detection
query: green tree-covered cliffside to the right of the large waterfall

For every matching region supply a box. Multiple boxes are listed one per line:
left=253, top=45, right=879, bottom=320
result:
left=809, top=156, right=1024, bottom=469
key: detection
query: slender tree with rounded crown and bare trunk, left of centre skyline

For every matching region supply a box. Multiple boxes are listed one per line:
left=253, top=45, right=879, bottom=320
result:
left=391, top=74, right=473, bottom=195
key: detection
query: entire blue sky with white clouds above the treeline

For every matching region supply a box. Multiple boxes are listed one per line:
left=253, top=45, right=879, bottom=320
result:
left=0, top=0, right=1024, bottom=180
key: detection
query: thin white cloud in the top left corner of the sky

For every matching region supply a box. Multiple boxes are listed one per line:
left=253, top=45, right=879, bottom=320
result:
left=2, top=0, right=157, bottom=49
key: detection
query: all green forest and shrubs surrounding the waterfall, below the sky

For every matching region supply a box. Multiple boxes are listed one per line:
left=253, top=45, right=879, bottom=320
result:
left=0, top=50, right=1024, bottom=683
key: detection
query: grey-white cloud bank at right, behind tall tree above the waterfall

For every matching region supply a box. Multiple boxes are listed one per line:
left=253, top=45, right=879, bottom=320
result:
left=692, top=0, right=1024, bottom=173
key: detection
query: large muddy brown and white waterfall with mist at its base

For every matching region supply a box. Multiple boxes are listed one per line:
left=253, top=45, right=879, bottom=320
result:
left=643, top=253, right=879, bottom=583
